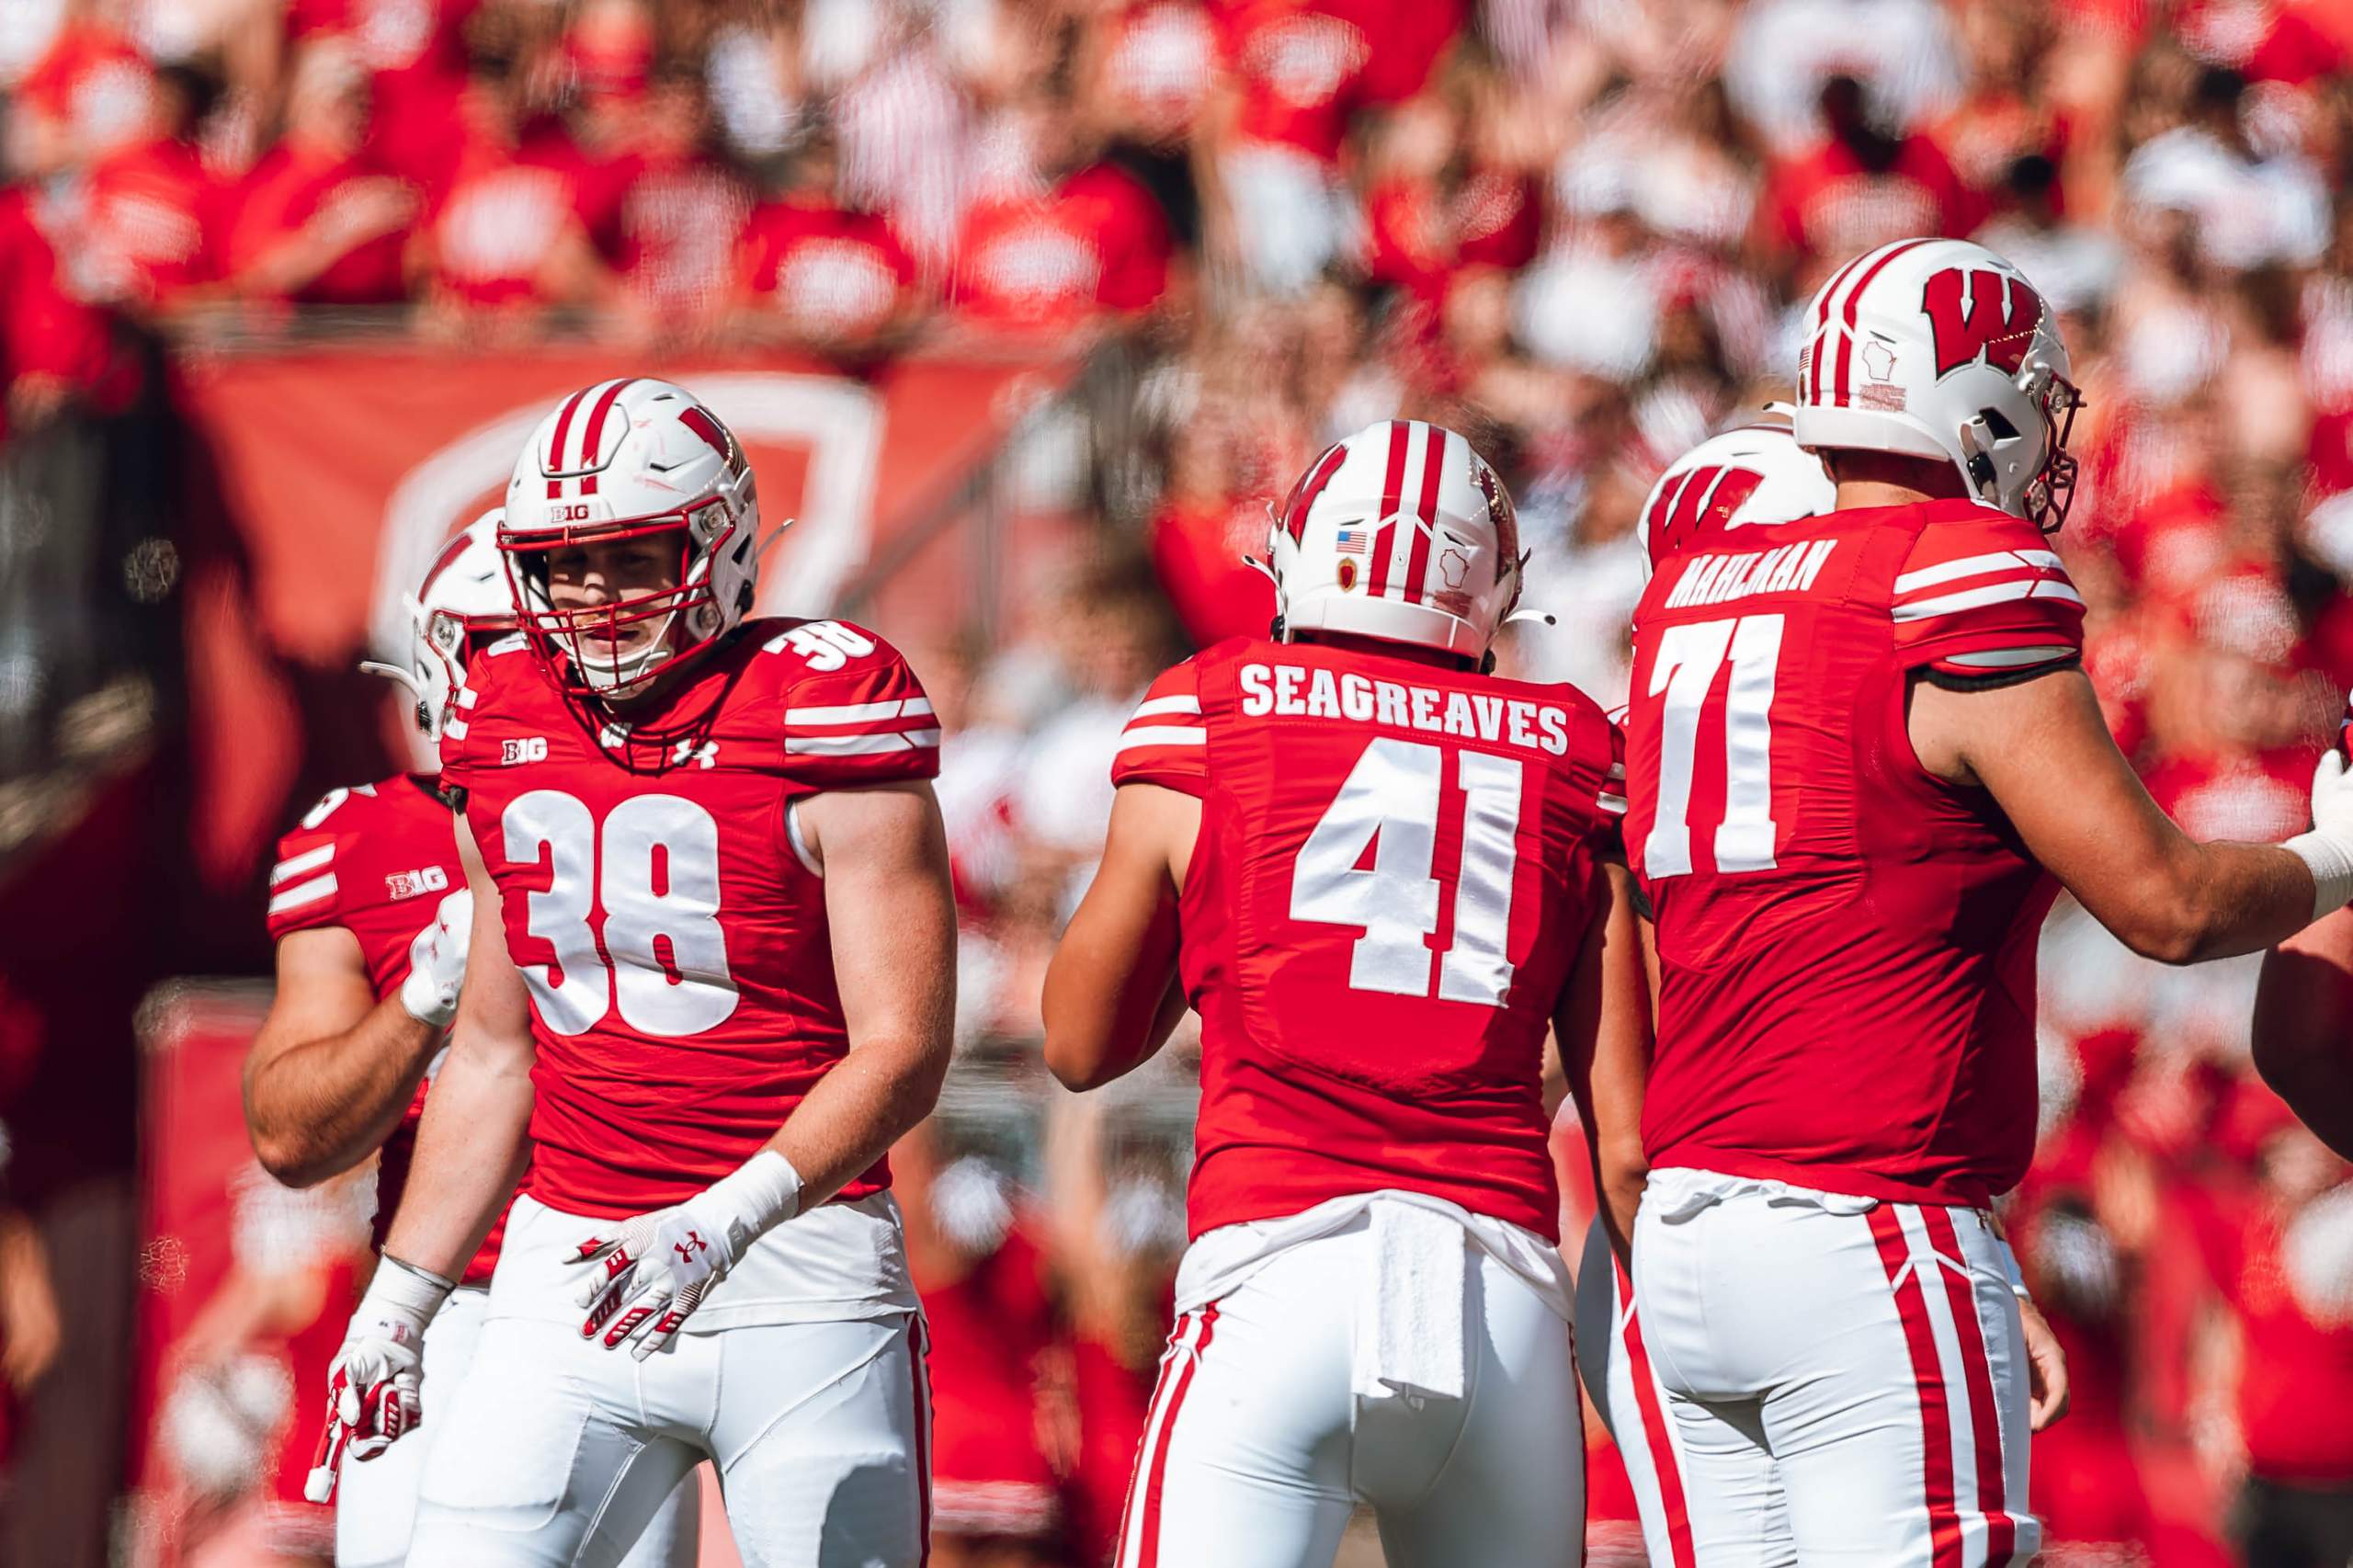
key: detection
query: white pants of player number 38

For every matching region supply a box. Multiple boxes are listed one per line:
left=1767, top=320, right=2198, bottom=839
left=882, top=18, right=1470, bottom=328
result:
left=412, top=1206, right=932, bottom=1568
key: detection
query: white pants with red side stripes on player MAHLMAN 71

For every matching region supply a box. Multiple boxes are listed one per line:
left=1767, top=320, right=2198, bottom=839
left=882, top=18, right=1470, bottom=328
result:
left=1623, top=1168, right=2042, bottom=1568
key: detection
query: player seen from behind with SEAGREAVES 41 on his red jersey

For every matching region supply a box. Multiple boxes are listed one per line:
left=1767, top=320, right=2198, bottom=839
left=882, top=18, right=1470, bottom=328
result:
left=1045, top=419, right=1650, bottom=1568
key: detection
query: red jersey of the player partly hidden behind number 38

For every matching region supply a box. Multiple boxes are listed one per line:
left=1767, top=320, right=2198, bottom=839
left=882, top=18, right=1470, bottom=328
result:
left=270, top=772, right=506, bottom=1286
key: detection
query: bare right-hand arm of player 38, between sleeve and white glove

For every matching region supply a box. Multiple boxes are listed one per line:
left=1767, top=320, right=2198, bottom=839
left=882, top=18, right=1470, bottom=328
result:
left=769, top=784, right=955, bottom=1208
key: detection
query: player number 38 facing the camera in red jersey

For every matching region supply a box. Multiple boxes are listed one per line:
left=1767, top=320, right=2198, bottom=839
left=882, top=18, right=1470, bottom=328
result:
left=317, top=379, right=955, bottom=1568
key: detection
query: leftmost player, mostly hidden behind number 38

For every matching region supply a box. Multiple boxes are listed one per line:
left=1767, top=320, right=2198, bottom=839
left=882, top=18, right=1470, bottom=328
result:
left=262, top=513, right=701, bottom=1568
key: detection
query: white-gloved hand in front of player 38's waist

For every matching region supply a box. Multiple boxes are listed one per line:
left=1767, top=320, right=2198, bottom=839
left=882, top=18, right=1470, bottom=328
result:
left=572, top=1149, right=800, bottom=1361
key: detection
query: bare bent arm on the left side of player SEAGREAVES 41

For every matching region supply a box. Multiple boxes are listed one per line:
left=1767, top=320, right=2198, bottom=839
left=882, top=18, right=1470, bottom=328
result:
left=1045, top=784, right=1200, bottom=1090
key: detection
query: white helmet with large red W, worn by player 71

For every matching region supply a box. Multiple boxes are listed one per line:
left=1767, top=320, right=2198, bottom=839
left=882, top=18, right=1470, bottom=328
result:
left=1793, top=240, right=2083, bottom=532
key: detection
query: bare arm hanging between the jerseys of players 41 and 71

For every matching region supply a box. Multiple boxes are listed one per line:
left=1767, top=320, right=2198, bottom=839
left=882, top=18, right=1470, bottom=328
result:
left=1553, top=864, right=1652, bottom=1257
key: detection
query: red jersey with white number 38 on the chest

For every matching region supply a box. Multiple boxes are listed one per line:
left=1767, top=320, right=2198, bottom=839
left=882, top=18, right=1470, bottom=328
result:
left=442, top=619, right=938, bottom=1220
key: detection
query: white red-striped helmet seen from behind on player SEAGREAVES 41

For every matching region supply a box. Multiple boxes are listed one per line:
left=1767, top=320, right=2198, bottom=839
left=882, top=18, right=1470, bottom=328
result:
left=1268, top=419, right=1527, bottom=659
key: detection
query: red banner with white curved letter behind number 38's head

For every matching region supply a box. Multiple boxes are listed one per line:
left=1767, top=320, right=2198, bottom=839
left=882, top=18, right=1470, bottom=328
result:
left=181, top=347, right=1066, bottom=885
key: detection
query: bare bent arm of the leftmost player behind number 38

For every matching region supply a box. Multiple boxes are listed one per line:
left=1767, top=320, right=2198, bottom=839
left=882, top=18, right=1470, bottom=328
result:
left=244, top=927, right=440, bottom=1187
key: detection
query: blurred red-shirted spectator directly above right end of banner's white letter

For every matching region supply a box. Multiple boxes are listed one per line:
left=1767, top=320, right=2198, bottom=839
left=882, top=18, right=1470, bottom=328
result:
left=736, top=131, right=917, bottom=353
